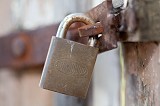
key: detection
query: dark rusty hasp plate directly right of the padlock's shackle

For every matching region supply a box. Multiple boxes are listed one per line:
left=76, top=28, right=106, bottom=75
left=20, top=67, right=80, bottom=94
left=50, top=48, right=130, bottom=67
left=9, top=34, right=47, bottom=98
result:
left=86, top=0, right=120, bottom=52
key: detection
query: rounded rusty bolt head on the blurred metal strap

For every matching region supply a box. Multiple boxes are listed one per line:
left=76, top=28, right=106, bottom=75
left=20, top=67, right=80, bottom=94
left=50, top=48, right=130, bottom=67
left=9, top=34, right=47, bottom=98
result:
left=11, top=38, right=26, bottom=57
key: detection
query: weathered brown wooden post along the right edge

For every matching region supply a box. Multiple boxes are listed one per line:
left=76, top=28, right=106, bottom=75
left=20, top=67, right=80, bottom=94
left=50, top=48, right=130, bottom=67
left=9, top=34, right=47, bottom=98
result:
left=123, top=0, right=160, bottom=106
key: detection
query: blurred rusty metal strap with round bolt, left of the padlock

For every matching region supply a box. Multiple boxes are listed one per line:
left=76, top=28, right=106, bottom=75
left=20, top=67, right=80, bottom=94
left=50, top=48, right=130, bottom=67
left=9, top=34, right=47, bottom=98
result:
left=0, top=25, right=58, bottom=68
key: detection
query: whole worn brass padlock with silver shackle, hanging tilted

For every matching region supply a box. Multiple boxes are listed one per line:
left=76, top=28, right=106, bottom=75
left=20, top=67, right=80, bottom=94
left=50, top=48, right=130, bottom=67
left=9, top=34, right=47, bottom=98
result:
left=39, top=13, right=99, bottom=98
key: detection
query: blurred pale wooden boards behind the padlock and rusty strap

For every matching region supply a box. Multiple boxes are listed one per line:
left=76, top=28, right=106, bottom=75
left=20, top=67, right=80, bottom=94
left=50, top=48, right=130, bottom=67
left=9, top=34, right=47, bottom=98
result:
left=0, top=0, right=120, bottom=106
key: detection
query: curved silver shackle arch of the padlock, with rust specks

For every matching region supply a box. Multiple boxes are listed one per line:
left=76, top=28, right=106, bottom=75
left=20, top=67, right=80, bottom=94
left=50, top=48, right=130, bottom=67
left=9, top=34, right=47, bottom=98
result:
left=56, top=13, right=95, bottom=38
